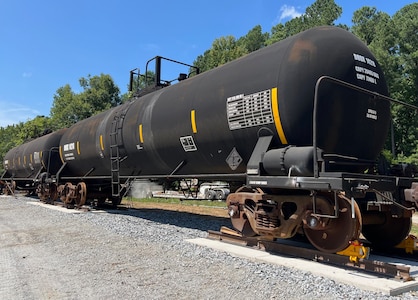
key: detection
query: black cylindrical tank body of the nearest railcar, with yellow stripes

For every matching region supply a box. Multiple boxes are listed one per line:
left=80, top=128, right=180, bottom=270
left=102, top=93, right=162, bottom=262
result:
left=60, top=27, right=390, bottom=177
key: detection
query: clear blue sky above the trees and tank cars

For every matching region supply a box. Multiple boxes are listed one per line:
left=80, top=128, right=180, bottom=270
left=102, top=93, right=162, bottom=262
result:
left=0, top=0, right=415, bottom=127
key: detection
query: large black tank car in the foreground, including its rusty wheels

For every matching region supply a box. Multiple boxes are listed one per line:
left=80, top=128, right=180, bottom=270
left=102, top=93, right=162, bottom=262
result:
left=1, top=27, right=418, bottom=252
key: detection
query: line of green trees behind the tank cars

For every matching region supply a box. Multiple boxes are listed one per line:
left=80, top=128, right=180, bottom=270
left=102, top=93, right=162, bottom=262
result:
left=0, top=0, right=418, bottom=170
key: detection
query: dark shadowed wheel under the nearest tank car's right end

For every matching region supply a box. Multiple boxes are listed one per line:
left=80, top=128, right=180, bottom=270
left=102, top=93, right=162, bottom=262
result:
left=362, top=211, right=412, bottom=250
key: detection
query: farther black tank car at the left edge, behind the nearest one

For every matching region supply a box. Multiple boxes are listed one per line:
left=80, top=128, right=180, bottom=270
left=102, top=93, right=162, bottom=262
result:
left=2, top=129, right=66, bottom=189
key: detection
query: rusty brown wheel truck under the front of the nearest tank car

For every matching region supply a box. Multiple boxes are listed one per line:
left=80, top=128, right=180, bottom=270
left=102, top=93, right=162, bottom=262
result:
left=227, top=190, right=361, bottom=253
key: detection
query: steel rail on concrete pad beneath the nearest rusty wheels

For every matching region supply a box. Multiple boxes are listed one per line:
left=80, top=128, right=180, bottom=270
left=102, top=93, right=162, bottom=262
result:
left=208, top=228, right=416, bottom=282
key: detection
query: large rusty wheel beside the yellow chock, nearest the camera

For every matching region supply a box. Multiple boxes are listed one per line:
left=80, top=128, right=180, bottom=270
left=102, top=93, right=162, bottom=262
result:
left=303, top=197, right=362, bottom=253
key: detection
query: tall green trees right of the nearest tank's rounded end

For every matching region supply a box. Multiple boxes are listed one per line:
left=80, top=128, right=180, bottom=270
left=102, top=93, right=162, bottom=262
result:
left=351, top=3, right=418, bottom=163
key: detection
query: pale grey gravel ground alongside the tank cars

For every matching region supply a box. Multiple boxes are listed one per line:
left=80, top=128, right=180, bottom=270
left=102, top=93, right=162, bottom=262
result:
left=0, top=196, right=418, bottom=299
